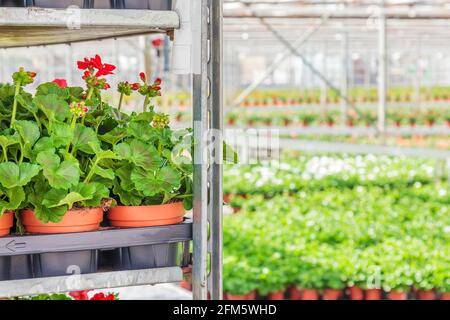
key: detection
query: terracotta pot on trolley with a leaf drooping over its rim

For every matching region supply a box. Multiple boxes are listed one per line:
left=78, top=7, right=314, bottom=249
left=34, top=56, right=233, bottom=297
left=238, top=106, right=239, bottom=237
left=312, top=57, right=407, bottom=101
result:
left=22, top=208, right=103, bottom=234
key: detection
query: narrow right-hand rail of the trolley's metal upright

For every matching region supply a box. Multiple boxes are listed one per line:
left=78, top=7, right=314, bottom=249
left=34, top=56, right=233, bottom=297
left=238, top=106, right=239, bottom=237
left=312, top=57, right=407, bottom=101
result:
left=208, top=0, right=223, bottom=300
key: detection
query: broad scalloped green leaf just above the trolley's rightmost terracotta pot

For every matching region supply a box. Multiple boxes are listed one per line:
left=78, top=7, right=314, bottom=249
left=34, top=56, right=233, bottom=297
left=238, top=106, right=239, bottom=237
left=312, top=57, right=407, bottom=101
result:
left=131, top=167, right=181, bottom=197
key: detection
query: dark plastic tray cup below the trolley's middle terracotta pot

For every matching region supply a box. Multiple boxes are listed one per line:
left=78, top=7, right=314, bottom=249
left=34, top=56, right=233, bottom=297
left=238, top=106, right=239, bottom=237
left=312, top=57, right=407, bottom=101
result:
left=33, top=250, right=98, bottom=278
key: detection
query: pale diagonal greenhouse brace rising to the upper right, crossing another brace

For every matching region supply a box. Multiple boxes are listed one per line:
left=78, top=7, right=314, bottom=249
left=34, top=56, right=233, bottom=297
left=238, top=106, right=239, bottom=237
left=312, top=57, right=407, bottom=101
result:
left=233, top=13, right=331, bottom=106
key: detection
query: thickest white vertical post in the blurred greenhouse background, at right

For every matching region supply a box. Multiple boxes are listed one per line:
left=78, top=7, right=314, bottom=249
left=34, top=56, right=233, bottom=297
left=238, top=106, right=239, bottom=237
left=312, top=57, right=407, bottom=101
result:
left=377, top=0, right=387, bottom=134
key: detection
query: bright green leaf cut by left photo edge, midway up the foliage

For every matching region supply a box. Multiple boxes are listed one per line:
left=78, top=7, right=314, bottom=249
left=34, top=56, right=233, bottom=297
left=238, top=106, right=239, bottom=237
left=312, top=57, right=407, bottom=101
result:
left=0, top=162, right=41, bottom=188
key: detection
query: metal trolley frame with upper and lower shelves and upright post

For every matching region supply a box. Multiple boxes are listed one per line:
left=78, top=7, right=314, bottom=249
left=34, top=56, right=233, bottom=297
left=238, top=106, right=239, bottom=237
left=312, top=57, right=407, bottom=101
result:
left=0, top=0, right=223, bottom=300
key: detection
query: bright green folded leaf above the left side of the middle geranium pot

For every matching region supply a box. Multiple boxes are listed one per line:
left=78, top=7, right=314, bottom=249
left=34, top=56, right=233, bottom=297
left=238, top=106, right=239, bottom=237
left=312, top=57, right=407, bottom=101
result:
left=36, top=151, right=80, bottom=189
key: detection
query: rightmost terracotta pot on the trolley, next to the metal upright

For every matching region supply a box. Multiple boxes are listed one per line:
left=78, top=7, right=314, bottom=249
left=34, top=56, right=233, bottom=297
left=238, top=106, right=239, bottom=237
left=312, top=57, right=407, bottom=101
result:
left=109, top=202, right=185, bottom=228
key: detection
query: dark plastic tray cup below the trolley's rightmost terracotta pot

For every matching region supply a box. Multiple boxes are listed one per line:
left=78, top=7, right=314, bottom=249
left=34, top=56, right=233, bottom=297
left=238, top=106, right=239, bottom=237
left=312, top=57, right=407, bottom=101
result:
left=115, top=243, right=183, bottom=270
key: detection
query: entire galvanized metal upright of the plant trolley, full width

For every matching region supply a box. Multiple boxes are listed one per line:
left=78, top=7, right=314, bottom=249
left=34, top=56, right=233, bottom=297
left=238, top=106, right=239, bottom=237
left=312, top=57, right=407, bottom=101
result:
left=192, top=0, right=223, bottom=300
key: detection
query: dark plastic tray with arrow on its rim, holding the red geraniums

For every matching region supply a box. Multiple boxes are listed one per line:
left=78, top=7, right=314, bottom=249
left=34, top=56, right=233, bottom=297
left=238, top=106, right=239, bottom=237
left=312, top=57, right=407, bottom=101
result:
left=0, top=220, right=192, bottom=281
